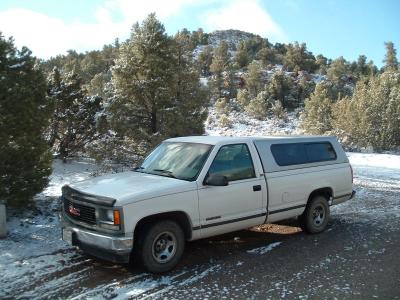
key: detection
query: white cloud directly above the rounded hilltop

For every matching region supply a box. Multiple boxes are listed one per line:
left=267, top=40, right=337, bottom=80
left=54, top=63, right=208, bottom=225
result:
left=204, top=0, right=288, bottom=42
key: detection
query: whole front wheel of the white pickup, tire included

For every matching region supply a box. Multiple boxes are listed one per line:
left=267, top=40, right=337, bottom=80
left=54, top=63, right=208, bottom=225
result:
left=137, top=220, right=185, bottom=273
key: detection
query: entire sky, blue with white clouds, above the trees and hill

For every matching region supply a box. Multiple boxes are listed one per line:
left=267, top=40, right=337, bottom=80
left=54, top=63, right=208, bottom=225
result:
left=0, top=0, right=400, bottom=66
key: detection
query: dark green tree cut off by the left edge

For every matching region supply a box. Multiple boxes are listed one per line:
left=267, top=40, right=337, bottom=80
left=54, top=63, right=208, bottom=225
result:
left=0, top=33, right=51, bottom=207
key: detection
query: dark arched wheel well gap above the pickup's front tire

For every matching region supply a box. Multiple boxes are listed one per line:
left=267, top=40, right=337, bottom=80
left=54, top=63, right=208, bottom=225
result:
left=134, top=211, right=192, bottom=241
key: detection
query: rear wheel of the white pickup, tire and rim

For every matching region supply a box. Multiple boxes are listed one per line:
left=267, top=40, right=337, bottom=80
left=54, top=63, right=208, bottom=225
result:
left=298, top=195, right=330, bottom=233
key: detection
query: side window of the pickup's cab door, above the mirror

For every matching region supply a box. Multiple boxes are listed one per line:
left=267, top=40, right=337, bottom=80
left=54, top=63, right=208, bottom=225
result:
left=208, top=144, right=256, bottom=181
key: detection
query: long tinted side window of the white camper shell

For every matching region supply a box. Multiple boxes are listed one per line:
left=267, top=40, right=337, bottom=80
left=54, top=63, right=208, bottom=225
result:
left=271, top=142, right=337, bottom=167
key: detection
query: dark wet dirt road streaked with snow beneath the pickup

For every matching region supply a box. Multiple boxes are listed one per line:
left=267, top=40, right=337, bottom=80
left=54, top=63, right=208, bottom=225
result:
left=0, top=154, right=400, bottom=299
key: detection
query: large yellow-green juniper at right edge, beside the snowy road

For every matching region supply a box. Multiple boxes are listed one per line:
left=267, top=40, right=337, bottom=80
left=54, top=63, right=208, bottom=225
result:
left=334, top=71, right=400, bottom=150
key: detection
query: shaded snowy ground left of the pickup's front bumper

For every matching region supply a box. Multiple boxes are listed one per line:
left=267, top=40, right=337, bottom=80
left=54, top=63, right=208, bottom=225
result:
left=0, top=160, right=100, bottom=298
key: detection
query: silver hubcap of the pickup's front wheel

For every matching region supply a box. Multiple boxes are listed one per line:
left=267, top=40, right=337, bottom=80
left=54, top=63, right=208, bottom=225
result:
left=152, top=231, right=176, bottom=264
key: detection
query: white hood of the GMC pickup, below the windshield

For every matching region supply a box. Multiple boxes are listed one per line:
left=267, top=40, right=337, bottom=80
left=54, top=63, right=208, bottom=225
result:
left=69, top=171, right=197, bottom=206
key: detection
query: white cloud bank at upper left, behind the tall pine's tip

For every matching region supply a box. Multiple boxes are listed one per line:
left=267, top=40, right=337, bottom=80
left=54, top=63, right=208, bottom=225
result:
left=0, top=0, right=195, bottom=58
